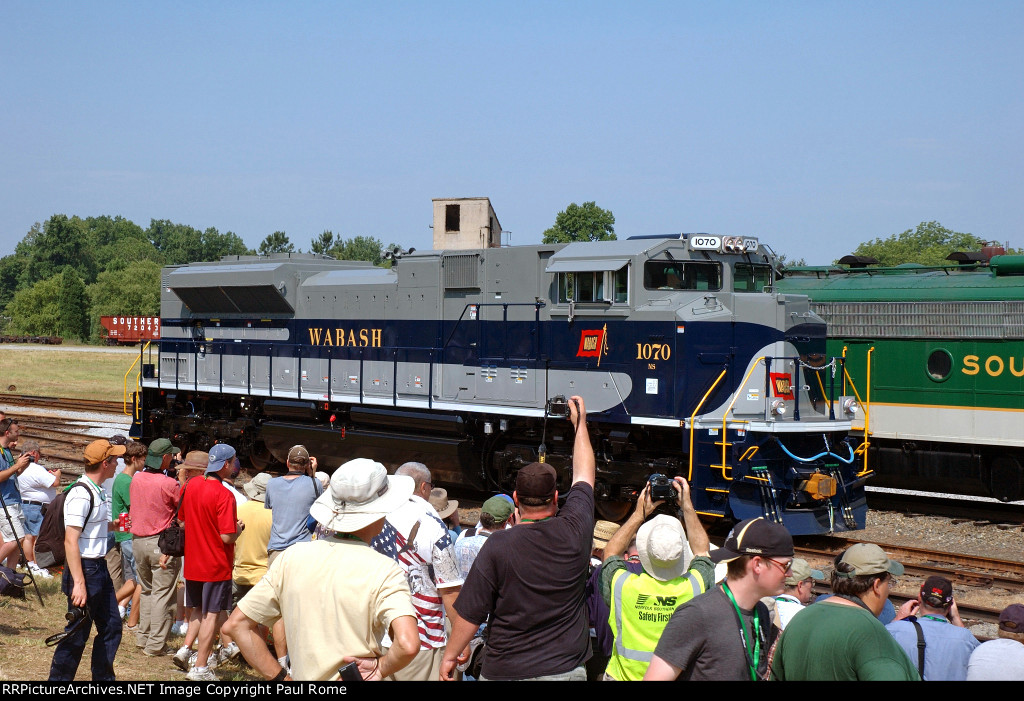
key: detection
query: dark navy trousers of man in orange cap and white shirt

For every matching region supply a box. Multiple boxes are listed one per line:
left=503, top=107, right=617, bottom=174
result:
left=49, top=558, right=121, bottom=682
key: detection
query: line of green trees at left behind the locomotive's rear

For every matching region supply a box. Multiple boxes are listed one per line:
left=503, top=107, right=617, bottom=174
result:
left=0, top=214, right=393, bottom=342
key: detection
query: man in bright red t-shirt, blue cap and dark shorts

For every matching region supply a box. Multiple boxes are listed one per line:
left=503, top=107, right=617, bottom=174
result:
left=179, top=443, right=245, bottom=682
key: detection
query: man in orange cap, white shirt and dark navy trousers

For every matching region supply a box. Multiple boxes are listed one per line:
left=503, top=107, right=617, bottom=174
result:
left=49, top=438, right=125, bottom=682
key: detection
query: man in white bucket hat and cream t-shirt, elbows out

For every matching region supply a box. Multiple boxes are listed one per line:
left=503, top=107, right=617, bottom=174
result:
left=224, top=457, right=420, bottom=681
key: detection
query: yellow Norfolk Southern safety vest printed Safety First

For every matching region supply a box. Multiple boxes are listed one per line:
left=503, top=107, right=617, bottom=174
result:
left=606, top=569, right=705, bottom=682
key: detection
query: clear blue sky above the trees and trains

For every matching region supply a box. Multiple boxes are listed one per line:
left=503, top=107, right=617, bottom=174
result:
left=0, top=0, right=1024, bottom=263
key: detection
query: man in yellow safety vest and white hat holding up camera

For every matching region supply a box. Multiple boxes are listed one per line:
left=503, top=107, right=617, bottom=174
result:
left=600, top=477, right=715, bottom=682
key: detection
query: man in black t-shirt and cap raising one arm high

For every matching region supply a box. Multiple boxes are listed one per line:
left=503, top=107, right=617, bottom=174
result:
left=440, top=396, right=595, bottom=682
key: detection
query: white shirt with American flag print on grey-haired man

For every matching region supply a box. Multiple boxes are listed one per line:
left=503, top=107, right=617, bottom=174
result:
left=370, top=496, right=463, bottom=650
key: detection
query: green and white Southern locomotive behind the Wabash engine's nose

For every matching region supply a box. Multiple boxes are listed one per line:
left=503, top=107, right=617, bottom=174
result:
left=778, top=254, right=1024, bottom=501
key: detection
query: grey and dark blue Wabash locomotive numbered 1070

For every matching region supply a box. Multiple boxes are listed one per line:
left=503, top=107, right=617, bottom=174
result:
left=136, top=215, right=867, bottom=534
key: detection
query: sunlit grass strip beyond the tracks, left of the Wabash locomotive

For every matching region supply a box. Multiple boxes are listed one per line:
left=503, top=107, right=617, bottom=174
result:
left=0, top=345, right=138, bottom=401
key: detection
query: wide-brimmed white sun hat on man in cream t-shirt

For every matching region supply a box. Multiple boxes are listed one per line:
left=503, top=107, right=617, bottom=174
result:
left=309, top=457, right=415, bottom=533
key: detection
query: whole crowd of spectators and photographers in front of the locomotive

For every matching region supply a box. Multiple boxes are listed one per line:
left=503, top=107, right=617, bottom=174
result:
left=0, top=397, right=1024, bottom=682
